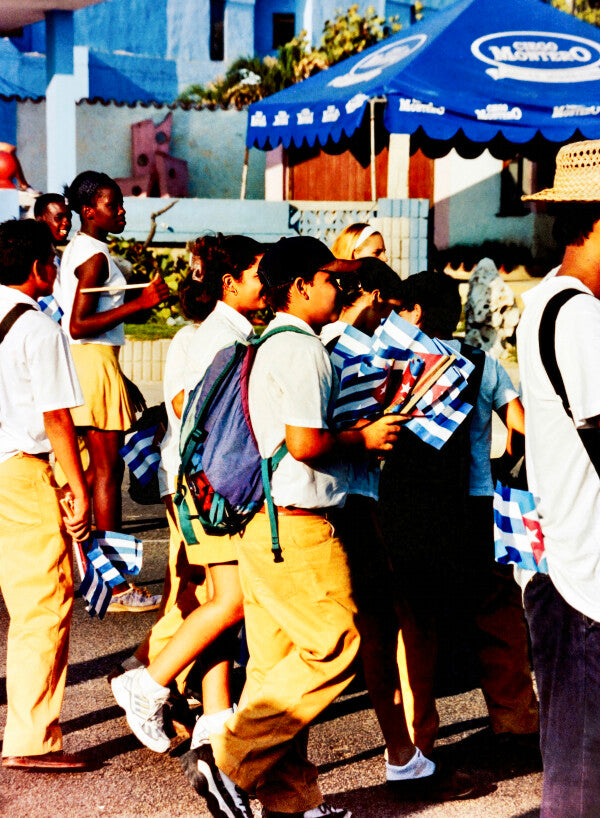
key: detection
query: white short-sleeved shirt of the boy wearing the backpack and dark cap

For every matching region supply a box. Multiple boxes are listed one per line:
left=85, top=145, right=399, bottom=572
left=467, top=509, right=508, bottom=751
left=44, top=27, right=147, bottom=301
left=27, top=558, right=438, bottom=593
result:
left=248, top=313, right=349, bottom=508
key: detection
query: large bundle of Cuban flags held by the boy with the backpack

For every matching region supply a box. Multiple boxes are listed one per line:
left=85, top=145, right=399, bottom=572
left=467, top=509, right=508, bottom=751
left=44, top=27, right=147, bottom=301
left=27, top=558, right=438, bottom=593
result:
left=331, top=313, right=474, bottom=449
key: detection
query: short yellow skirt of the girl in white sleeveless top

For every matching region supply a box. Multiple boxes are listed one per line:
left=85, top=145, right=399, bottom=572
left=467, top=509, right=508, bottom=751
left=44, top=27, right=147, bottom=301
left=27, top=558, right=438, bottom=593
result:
left=71, top=344, right=135, bottom=431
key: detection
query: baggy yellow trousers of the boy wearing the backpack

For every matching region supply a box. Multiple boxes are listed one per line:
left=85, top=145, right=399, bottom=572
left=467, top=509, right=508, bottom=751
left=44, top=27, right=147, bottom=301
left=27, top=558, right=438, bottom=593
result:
left=211, top=514, right=359, bottom=812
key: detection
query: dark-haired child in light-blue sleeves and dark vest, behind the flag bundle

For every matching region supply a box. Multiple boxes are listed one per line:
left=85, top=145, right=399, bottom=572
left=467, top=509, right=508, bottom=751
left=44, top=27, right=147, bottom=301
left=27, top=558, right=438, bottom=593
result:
left=379, top=272, right=538, bottom=753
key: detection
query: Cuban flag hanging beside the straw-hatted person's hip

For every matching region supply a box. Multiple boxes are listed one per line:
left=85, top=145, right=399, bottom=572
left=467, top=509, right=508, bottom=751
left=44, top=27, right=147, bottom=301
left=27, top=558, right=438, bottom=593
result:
left=494, top=483, right=548, bottom=574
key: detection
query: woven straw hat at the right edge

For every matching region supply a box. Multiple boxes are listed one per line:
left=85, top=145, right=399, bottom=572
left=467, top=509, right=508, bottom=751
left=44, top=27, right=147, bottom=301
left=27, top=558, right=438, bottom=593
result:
left=521, top=139, right=600, bottom=202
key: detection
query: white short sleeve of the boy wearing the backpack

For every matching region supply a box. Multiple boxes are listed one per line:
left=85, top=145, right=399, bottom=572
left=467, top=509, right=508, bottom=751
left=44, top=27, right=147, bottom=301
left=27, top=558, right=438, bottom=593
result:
left=271, top=342, right=332, bottom=429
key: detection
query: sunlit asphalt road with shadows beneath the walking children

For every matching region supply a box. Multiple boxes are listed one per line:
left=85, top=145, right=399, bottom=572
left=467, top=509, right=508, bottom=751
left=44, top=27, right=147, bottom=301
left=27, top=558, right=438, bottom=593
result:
left=0, top=384, right=541, bottom=818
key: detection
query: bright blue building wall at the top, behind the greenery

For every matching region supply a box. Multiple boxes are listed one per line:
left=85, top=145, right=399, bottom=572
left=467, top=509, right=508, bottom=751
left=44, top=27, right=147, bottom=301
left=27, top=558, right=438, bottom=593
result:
left=0, top=0, right=453, bottom=102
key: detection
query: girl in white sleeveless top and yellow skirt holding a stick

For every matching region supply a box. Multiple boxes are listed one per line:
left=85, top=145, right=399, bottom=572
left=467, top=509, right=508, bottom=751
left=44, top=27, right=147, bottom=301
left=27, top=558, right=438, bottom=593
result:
left=57, top=170, right=169, bottom=611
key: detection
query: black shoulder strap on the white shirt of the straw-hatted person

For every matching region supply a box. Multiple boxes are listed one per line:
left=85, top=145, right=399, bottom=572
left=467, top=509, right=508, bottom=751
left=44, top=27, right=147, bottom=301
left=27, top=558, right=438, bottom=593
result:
left=538, top=287, right=600, bottom=477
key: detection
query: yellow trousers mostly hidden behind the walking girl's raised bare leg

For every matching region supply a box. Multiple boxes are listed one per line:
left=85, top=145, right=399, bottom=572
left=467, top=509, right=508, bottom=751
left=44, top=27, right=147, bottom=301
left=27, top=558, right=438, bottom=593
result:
left=135, top=495, right=207, bottom=693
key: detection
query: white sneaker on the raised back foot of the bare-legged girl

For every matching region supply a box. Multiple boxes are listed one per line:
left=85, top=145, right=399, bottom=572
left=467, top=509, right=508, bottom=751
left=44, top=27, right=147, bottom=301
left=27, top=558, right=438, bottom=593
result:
left=110, top=667, right=171, bottom=753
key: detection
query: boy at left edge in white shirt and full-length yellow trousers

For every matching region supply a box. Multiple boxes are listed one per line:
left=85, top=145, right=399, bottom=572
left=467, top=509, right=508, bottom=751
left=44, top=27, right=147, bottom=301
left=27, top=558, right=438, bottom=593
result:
left=0, top=219, right=89, bottom=771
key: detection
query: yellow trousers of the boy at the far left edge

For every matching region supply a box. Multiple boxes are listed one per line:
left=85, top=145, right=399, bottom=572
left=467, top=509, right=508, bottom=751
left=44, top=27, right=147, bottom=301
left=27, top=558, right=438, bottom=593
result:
left=0, top=454, right=73, bottom=756
